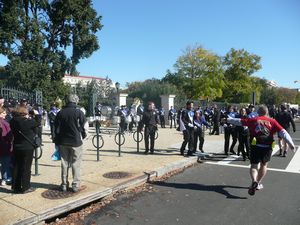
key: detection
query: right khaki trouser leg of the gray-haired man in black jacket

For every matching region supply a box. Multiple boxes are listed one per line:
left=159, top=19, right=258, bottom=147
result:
left=72, top=146, right=83, bottom=192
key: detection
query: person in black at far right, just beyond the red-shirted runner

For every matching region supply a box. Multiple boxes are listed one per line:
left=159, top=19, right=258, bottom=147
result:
left=275, top=104, right=296, bottom=157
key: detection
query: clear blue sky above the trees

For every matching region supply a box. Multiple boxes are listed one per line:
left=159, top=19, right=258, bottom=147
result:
left=0, top=0, right=300, bottom=88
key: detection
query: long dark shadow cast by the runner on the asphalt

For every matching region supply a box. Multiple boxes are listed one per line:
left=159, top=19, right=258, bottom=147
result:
left=149, top=181, right=248, bottom=199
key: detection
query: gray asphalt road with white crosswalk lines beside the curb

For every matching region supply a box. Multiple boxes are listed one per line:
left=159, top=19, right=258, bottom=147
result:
left=84, top=123, right=300, bottom=225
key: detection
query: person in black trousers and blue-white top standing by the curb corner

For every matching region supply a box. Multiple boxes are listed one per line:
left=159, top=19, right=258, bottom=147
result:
left=180, top=101, right=195, bottom=156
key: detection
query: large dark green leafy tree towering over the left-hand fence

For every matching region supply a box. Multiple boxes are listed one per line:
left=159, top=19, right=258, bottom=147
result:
left=0, top=0, right=102, bottom=105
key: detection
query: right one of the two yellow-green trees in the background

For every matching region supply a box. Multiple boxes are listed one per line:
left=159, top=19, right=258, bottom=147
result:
left=222, top=48, right=261, bottom=103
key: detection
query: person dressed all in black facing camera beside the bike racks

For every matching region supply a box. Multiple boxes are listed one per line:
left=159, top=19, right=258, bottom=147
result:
left=142, top=102, right=158, bottom=154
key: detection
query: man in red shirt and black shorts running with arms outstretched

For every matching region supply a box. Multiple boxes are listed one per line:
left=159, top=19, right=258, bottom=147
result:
left=227, top=105, right=295, bottom=195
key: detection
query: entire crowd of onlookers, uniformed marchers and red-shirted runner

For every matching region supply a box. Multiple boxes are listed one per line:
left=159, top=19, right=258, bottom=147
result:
left=0, top=95, right=297, bottom=195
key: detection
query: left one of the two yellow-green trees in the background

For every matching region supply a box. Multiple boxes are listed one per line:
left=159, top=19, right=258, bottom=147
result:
left=163, top=46, right=224, bottom=99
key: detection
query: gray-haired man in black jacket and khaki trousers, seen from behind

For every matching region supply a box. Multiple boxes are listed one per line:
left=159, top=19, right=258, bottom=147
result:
left=55, top=94, right=86, bottom=192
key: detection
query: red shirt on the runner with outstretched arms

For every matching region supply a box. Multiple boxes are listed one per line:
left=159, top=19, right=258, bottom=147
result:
left=241, top=116, right=283, bottom=144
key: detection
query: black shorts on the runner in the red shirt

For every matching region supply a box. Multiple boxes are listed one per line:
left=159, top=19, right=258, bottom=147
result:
left=250, top=145, right=272, bottom=164
